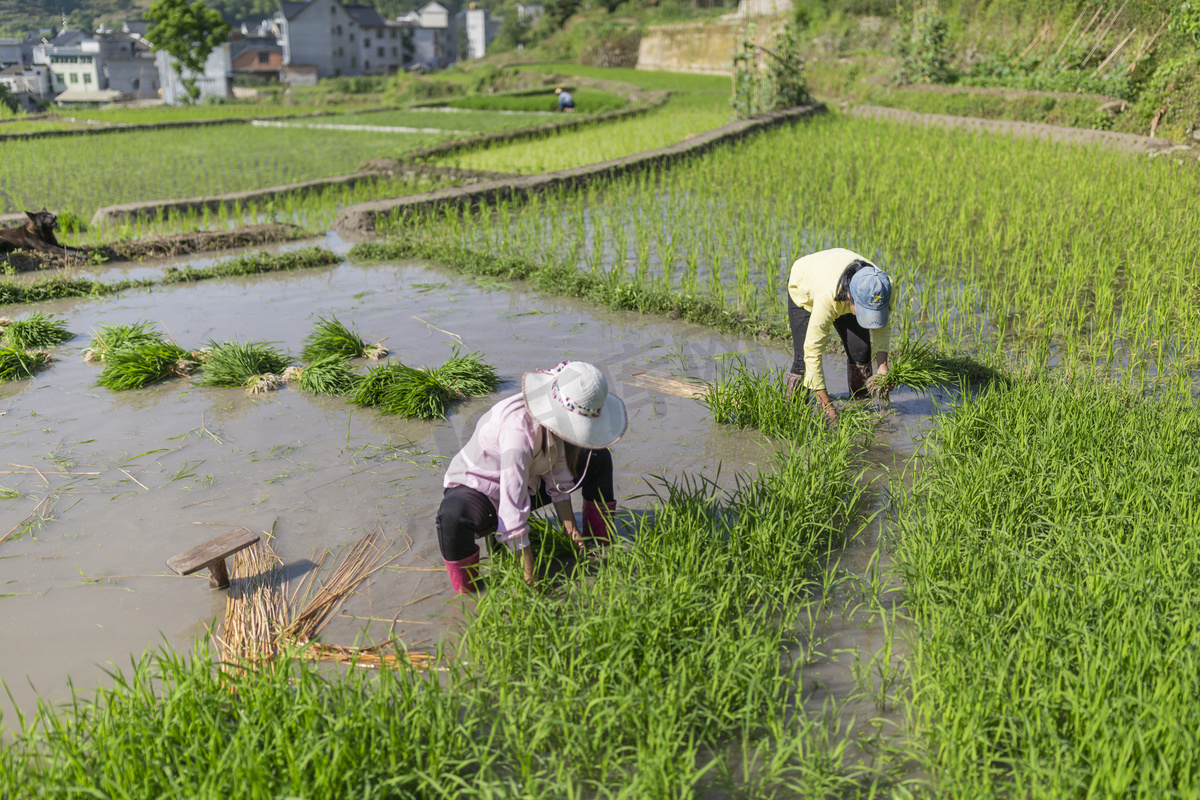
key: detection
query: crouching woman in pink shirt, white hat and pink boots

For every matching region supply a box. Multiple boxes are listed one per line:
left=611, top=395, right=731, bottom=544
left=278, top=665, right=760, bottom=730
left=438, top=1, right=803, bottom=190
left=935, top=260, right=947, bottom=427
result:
left=437, top=361, right=628, bottom=593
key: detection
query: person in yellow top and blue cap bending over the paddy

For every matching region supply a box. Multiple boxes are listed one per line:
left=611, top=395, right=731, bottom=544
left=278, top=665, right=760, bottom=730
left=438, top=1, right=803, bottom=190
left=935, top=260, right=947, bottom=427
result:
left=787, top=248, right=892, bottom=422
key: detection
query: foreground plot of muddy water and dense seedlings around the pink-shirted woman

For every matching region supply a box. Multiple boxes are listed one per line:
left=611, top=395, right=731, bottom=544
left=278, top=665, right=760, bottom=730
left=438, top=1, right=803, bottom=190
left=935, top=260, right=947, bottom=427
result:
left=0, top=248, right=907, bottom=798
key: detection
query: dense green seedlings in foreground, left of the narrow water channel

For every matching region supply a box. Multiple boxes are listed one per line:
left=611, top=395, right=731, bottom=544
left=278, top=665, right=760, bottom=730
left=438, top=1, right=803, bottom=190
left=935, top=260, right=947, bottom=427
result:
left=0, top=417, right=887, bottom=798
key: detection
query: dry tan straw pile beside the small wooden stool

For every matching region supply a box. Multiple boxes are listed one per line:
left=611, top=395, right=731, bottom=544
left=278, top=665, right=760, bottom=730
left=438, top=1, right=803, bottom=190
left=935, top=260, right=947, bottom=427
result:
left=216, top=530, right=431, bottom=670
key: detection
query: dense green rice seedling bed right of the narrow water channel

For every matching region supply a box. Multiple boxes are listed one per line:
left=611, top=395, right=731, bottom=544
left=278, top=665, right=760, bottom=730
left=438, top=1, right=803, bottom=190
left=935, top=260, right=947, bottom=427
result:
left=895, top=377, right=1200, bottom=799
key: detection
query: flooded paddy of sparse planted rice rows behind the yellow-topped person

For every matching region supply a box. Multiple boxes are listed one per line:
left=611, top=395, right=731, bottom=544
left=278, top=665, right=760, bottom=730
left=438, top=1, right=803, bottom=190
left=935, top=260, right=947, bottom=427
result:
left=402, top=112, right=1200, bottom=379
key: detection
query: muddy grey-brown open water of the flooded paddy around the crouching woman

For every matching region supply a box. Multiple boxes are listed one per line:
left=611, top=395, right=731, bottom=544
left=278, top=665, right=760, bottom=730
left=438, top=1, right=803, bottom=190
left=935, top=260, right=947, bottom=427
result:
left=0, top=248, right=929, bottom=758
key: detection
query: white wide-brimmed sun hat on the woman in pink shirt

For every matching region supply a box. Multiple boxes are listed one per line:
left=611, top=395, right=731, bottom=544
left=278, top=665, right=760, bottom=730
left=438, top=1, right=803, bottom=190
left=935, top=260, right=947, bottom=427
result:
left=521, top=361, right=629, bottom=450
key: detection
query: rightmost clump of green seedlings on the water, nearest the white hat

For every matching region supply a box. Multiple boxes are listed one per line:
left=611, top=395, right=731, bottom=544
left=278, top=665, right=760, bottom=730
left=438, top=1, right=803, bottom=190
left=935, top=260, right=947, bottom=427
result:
left=352, top=350, right=500, bottom=420
